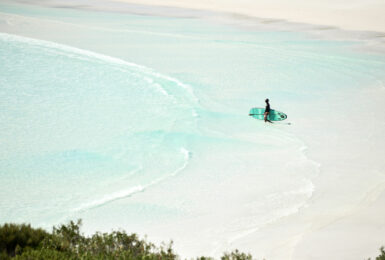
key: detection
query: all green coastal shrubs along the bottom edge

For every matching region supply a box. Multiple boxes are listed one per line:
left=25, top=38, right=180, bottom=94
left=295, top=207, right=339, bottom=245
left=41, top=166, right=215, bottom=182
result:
left=0, top=220, right=385, bottom=260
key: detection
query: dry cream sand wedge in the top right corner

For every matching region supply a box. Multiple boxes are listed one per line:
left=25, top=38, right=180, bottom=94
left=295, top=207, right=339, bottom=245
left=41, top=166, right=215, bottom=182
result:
left=108, top=0, right=385, bottom=32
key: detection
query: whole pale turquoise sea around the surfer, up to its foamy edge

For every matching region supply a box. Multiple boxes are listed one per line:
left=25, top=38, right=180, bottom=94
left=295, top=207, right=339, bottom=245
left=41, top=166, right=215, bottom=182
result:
left=0, top=1, right=385, bottom=255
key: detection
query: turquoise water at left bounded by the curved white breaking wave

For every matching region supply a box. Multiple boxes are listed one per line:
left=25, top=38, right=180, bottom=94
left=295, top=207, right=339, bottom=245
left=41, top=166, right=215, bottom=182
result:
left=0, top=34, right=198, bottom=223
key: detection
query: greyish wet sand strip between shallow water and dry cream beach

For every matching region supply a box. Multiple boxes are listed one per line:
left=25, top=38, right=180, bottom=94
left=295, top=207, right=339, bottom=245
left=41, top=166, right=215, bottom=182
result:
left=8, top=0, right=385, bottom=54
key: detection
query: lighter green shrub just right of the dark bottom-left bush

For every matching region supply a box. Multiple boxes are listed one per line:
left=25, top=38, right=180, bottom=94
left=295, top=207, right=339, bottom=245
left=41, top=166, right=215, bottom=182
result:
left=37, top=220, right=177, bottom=260
